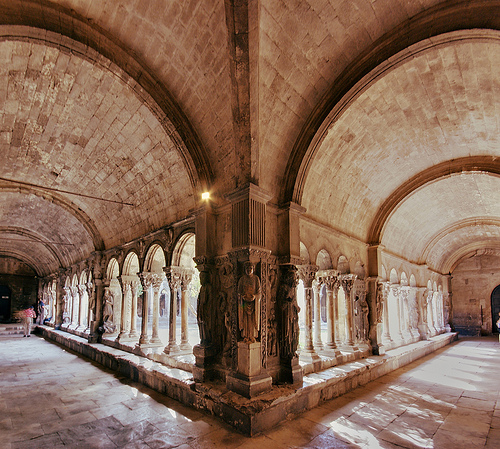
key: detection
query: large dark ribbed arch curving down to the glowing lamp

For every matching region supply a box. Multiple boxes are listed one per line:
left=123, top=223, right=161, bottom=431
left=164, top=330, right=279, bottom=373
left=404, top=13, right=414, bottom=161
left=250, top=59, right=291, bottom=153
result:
left=0, top=4, right=213, bottom=193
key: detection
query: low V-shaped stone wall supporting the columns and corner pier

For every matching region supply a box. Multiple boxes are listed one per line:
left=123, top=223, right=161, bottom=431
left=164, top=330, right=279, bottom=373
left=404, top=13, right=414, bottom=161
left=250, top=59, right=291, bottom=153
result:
left=37, top=326, right=457, bottom=435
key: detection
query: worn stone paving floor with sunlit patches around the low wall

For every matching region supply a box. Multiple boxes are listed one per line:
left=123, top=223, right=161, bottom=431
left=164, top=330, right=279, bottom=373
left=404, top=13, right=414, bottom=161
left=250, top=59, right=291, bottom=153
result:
left=0, top=335, right=500, bottom=449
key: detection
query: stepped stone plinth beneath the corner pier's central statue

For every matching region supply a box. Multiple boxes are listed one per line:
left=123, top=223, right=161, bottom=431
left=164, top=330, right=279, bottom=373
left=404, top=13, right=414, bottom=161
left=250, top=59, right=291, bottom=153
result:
left=226, top=341, right=273, bottom=398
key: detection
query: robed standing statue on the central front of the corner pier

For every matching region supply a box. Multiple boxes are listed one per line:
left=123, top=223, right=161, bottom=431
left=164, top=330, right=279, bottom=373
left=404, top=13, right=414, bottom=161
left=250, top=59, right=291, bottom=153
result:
left=238, top=261, right=262, bottom=343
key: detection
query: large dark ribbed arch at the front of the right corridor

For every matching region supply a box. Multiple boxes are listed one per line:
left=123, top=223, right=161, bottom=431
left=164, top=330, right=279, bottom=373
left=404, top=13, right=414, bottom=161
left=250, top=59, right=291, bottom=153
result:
left=281, top=8, right=500, bottom=204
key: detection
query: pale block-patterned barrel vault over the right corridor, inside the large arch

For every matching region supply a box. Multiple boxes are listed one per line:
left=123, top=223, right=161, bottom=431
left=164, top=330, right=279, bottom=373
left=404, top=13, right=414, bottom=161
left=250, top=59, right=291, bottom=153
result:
left=302, top=30, right=500, bottom=270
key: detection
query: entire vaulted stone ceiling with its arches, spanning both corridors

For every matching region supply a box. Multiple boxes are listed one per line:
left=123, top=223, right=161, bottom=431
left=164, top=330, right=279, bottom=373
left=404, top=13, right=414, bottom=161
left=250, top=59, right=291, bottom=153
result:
left=0, top=0, right=500, bottom=275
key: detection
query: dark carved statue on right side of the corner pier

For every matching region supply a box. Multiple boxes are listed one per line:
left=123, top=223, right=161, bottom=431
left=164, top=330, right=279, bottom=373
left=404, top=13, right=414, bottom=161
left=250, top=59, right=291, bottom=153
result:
left=278, top=267, right=300, bottom=359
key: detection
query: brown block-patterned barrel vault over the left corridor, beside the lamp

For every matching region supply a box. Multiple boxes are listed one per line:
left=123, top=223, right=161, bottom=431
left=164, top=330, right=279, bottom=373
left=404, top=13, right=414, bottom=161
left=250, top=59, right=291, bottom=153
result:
left=0, top=39, right=194, bottom=275
